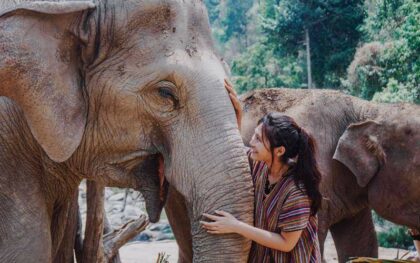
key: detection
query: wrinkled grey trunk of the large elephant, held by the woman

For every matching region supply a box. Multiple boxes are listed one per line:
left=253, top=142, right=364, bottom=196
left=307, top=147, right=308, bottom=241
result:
left=169, top=76, right=254, bottom=262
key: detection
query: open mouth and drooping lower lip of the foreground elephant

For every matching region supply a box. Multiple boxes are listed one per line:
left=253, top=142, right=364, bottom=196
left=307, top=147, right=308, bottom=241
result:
left=112, top=151, right=169, bottom=222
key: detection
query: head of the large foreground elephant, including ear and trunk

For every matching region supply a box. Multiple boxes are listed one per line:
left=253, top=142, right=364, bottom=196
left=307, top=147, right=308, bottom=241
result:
left=0, top=0, right=253, bottom=262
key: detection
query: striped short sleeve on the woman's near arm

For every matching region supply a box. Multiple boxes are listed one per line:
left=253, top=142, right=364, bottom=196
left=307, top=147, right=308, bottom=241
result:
left=278, top=187, right=311, bottom=232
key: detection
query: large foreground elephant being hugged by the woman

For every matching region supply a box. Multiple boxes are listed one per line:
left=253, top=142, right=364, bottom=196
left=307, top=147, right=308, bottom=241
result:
left=0, top=0, right=253, bottom=262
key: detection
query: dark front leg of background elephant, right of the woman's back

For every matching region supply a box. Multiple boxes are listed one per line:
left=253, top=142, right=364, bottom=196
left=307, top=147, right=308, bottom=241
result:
left=330, top=208, right=378, bottom=262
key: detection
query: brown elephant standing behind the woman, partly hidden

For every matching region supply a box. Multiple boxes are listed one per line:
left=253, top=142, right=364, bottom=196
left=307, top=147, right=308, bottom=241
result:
left=165, top=88, right=420, bottom=262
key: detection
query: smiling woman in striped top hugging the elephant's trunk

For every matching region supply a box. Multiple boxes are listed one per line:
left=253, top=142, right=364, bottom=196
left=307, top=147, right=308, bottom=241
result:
left=201, top=82, right=321, bottom=263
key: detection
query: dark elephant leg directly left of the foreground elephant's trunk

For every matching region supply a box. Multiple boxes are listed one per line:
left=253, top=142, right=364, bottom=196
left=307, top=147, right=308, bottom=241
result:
left=165, top=186, right=193, bottom=263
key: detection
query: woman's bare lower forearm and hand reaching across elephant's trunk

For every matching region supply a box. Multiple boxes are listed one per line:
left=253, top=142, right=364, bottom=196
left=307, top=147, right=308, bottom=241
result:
left=201, top=211, right=302, bottom=252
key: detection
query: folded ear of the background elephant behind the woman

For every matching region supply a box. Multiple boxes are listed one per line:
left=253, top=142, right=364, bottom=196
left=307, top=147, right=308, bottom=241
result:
left=333, top=121, right=386, bottom=187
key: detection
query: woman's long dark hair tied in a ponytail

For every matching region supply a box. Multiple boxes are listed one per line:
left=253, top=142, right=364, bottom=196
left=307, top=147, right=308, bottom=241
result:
left=258, top=112, right=322, bottom=215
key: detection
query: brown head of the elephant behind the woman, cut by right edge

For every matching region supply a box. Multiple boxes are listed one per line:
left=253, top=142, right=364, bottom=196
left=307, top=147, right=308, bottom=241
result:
left=333, top=117, right=420, bottom=231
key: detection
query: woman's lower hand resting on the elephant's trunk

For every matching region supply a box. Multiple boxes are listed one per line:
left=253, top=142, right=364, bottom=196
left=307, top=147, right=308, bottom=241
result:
left=200, top=210, right=240, bottom=234
